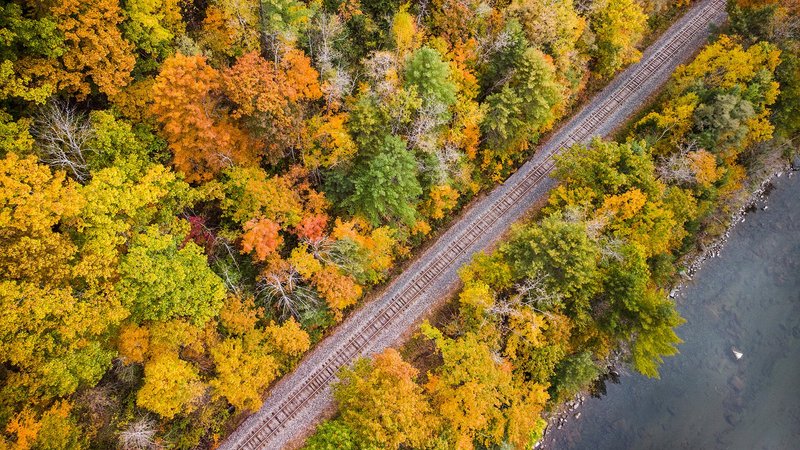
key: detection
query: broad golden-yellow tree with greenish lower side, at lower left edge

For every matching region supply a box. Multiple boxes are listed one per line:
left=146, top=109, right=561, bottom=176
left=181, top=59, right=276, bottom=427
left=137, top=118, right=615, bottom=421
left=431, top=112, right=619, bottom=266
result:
left=0, top=280, right=127, bottom=412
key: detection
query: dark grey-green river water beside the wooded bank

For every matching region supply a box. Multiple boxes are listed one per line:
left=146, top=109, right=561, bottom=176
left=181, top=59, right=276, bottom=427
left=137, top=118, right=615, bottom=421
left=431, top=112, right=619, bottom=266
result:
left=546, top=172, right=800, bottom=450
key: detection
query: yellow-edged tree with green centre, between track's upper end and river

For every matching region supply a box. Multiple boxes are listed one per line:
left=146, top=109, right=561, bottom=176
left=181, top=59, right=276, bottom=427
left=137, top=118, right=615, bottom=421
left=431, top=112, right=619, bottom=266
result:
left=637, top=36, right=780, bottom=160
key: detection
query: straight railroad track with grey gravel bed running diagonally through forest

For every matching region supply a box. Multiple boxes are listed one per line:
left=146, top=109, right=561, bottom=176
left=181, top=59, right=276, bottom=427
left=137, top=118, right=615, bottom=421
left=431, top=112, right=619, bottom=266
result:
left=220, top=0, right=726, bottom=450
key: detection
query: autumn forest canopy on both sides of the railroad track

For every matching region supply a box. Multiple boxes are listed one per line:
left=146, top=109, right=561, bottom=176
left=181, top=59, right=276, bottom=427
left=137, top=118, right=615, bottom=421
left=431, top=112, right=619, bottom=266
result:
left=0, top=0, right=800, bottom=450
